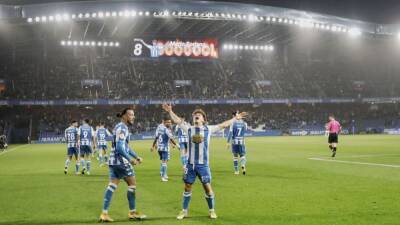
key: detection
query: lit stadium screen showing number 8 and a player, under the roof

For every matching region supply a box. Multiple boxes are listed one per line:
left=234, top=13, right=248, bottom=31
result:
left=131, top=38, right=219, bottom=59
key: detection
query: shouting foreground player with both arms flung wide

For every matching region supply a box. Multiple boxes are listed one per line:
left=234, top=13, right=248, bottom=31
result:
left=163, top=104, right=247, bottom=220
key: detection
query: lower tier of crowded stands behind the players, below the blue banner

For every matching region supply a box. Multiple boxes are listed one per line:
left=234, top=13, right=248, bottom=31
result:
left=0, top=103, right=400, bottom=143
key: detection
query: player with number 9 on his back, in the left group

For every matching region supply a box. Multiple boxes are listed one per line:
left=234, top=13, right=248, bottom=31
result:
left=78, top=119, right=95, bottom=175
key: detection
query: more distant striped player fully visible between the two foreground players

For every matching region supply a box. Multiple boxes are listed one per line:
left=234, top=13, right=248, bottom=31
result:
left=151, top=117, right=176, bottom=182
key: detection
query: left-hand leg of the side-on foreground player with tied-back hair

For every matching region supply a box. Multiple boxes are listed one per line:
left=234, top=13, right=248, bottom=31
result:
left=99, top=166, right=121, bottom=222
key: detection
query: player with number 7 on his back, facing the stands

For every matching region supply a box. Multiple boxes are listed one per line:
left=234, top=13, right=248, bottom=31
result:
left=227, top=112, right=247, bottom=175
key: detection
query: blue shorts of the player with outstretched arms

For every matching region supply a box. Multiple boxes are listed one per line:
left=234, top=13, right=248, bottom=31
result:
left=183, top=164, right=211, bottom=184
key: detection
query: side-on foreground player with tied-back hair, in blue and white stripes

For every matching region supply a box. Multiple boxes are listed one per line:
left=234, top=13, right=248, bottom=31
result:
left=99, top=108, right=146, bottom=222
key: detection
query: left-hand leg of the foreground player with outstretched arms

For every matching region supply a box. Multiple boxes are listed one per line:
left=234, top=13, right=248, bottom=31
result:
left=176, top=165, right=196, bottom=220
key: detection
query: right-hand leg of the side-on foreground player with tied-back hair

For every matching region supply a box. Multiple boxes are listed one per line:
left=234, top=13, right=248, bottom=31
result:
left=124, top=167, right=146, bottom=219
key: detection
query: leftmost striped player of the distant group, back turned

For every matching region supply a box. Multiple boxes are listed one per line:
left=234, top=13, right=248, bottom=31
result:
left=64, top=120, right=79, bottom=174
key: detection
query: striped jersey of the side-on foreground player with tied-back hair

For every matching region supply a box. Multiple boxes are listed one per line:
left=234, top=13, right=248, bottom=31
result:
left=108, top=122, right=129, bottom=165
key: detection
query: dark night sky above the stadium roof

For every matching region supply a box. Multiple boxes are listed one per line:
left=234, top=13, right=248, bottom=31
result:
left=0, top=0, right=400, bottom=23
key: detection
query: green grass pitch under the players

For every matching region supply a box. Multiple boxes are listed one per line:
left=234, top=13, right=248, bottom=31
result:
left=0, top=136, right=400, bottom=225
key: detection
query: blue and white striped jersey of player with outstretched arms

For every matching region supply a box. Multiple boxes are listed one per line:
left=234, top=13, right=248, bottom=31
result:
left=179, top=123, right=221, bottom=165
